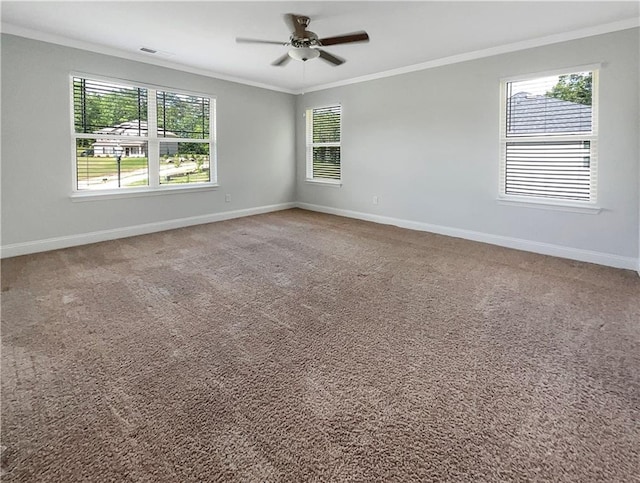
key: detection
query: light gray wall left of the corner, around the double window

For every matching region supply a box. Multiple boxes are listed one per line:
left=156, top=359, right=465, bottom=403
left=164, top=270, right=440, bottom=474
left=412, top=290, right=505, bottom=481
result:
left=2, top=35, right=295, bottom=250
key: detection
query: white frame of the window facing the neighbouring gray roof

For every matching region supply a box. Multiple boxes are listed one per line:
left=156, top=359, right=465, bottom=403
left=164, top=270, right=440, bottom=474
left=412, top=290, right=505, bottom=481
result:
left=498, top=64, right=601, bottom=208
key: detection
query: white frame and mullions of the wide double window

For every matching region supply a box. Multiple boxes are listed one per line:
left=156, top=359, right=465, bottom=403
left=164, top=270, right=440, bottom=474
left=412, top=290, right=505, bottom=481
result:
left=69, top=72, right=219, bottom=201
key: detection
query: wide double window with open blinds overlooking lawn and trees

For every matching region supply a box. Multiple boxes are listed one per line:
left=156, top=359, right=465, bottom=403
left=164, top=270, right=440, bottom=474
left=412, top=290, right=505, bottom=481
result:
left=72, top=77, right=216, bottom=191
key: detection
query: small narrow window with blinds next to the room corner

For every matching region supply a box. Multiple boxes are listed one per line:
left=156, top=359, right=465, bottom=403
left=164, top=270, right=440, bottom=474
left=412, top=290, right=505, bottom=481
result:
left=306, top=105, right=342, bottom=183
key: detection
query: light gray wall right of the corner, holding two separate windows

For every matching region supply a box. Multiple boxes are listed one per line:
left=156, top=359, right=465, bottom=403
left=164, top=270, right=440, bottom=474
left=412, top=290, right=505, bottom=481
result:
left=297, top=29, right=640, bottom=266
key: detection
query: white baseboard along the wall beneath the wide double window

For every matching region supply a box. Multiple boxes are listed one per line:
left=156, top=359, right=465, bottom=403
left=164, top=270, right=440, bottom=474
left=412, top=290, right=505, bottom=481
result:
left=0, top=203, right=296, bottom=258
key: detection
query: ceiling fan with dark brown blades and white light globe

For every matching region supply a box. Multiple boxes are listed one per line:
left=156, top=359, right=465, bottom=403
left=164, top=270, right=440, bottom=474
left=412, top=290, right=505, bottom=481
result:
left=236, top=13, right=369, bottom=66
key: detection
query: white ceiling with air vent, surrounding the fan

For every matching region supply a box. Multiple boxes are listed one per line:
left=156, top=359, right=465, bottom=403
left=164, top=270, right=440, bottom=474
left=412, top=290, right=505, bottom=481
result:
left=1, top=1, right=640, bottom=93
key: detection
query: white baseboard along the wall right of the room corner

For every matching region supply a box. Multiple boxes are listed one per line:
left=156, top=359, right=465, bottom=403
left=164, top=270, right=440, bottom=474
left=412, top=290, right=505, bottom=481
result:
left=297, top=203, right=640, bottom=274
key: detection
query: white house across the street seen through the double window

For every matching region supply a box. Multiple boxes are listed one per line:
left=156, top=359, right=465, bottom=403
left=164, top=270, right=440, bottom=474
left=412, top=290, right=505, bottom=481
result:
left=93, top=120, right=178, bottom=158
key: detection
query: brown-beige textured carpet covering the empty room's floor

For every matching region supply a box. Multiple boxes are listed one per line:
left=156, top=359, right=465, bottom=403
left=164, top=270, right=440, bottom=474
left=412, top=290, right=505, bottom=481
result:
left=2, top=210, right=640, bottom=482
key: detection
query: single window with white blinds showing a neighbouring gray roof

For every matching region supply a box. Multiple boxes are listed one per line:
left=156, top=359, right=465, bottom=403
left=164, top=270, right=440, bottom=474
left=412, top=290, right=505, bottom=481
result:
left=500, top=69, right=597, bottom=203
